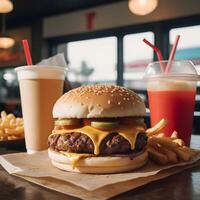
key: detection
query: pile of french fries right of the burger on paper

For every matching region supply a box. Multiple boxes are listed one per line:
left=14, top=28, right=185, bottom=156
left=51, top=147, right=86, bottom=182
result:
left=146, top=123, right=197, bottom=165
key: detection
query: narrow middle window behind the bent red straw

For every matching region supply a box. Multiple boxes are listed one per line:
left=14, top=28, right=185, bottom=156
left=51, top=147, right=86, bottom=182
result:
left=123, top=32, right=154, bottom=89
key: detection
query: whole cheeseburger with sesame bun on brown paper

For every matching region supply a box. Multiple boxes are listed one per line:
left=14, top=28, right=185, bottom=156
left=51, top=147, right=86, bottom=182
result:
left=48, top=85, right=148, bottom=174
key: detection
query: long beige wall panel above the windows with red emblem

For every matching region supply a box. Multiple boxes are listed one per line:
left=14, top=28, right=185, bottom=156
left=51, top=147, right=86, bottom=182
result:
left=43, top=0, right=200, bottom=38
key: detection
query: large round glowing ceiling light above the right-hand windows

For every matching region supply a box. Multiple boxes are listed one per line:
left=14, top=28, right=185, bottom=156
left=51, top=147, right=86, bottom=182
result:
left=128, top=0, right=158, bottom=15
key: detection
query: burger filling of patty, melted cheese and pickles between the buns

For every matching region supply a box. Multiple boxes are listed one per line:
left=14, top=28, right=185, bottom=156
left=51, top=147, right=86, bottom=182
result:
left=48, top=117, right=147, bottom=156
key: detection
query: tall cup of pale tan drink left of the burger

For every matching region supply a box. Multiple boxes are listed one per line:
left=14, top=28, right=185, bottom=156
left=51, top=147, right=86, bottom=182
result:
left=15, top=65, right=65, bottom=153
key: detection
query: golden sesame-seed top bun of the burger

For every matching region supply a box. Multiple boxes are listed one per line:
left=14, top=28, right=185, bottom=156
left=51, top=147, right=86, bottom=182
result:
left=53, top=85, right=146, bottom=118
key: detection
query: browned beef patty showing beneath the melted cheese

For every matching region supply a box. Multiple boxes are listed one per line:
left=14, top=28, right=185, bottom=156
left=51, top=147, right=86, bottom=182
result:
left=48, top=132, right=147, bottom=155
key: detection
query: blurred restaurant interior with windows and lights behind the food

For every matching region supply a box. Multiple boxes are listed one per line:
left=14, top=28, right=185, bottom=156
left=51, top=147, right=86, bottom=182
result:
left=0, top=0, right=200, bottom=134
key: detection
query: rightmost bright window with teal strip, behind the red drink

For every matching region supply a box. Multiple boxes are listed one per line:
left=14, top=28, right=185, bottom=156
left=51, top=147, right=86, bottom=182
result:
left=169, top=26, right=200, bottom=74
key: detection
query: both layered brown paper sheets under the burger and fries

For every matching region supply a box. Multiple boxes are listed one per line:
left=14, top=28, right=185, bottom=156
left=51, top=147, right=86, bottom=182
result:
left=0, top=151, right=200, bottom=200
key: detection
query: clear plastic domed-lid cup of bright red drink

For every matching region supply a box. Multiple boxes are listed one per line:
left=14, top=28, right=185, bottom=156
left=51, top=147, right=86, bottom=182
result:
left=144, top=60, right=200, bottom=146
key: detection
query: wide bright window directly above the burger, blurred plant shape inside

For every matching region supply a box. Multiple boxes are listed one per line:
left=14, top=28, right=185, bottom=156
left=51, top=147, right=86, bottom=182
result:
left=58, top=37, right=117, bottom=84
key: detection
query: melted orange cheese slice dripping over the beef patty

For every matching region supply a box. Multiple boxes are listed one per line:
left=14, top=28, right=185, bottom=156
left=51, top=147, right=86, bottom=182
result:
left=51, top=125, right=144, bottom=155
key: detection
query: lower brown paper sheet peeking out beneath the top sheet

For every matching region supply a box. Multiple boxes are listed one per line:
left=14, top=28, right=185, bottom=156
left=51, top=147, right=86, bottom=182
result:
left=14, top=161, right=200, bottom=200
